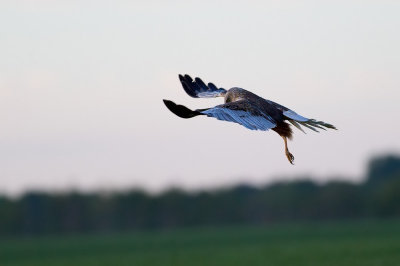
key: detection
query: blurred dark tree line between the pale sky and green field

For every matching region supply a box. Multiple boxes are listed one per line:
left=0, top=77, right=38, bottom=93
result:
left=0, top=156, right=400, bottom=235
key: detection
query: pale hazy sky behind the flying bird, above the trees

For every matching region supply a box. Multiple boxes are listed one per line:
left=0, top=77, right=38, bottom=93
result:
left=0, top=0, right=400, bottom=195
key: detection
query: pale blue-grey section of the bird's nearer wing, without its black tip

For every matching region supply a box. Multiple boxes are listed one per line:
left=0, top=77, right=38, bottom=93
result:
left=200, top=100, right=276, bottom=130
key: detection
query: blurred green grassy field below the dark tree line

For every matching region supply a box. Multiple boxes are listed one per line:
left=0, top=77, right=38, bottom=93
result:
left=0, top=221, right=400, bottom=266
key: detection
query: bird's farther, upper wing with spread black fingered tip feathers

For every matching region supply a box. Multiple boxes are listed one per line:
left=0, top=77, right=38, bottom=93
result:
left=179, top=75, right=226, bottom=98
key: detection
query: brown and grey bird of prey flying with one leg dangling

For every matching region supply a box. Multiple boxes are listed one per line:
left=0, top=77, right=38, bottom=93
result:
left=164, top=75, right=336, bottom=164
